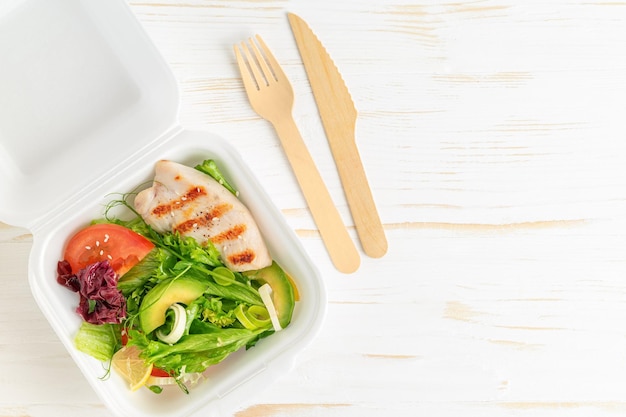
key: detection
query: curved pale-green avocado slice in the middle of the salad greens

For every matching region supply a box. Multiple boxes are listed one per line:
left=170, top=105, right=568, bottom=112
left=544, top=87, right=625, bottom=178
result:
left=139, top=277, right=206, bottom=334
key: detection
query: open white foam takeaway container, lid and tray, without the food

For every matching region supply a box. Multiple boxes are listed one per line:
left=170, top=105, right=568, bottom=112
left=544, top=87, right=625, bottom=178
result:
left=0, top=0, right=326, bottom=417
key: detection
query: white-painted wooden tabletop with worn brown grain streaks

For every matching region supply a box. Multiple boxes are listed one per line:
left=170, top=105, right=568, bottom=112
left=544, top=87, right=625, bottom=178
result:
left=0, top=0, right=626, bottom=417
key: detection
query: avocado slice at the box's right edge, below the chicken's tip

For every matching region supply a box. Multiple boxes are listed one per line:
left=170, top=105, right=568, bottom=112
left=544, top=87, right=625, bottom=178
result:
left=244, top=261, right=295, bottom=328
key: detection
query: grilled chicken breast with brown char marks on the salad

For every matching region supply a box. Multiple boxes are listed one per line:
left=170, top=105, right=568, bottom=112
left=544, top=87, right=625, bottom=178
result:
left=134, top=160, right=272, bottom=271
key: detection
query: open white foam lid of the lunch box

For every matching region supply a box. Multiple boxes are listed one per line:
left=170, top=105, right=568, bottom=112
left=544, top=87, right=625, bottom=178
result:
left=0, top=0, right=179, bottom=230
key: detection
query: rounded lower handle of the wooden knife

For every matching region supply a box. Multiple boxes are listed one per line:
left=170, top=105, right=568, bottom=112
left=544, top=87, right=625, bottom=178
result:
left=331, top=140, right=387, bottom=258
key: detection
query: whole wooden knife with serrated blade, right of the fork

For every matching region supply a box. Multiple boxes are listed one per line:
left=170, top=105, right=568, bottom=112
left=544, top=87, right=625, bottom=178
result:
left=287, top=13, right=387, bottom=258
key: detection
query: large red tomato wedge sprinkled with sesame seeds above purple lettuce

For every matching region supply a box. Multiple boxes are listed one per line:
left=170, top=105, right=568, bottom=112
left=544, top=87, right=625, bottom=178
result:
left=63, top=223, right=154, bottom=276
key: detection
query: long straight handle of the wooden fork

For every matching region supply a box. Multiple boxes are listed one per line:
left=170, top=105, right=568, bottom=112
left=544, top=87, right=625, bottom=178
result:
left=273, top=117, right=361, bottom=273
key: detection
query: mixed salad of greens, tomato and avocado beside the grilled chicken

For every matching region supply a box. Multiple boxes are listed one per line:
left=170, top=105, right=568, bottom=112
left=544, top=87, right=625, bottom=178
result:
left=57, top=160, right=298, bottom=393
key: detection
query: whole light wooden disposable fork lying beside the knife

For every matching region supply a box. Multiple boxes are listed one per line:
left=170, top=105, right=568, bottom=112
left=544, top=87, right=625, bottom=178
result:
left=234, top=35, right=361, bottom=273
